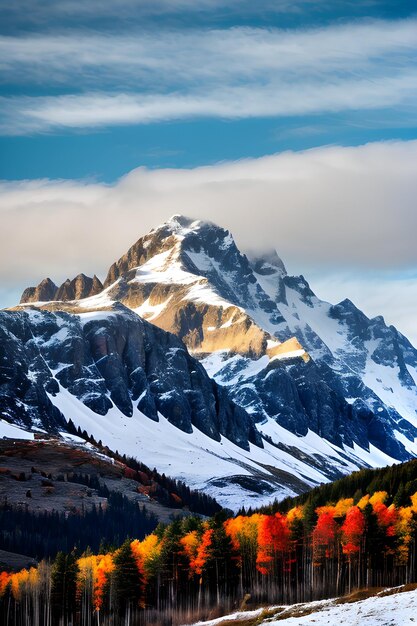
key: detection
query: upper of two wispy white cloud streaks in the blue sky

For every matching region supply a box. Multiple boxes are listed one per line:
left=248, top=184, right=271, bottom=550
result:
left=0, top=19, right=417, bottom=84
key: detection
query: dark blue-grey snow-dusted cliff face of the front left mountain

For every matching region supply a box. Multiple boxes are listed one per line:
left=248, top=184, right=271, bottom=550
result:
left=0, top=305, right=262, bottom=449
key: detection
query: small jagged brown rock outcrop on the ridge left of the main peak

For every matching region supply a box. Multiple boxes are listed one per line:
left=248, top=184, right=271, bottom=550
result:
left=20, top=274, right=103, bottom=304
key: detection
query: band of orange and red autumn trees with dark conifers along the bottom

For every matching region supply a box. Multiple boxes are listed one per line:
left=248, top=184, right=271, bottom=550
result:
left=0, top=480, right=417, bottom=626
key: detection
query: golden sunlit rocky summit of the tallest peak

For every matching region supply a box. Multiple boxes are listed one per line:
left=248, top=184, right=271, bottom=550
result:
left=96, top=216, right=290, bottom=358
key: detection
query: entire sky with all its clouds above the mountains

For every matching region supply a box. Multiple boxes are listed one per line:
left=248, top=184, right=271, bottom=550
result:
left=0, top=0, right=417, bottom=340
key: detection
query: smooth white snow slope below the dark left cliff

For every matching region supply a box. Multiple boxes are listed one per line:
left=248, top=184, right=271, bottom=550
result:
left=45, top=386, right=384, bottom=510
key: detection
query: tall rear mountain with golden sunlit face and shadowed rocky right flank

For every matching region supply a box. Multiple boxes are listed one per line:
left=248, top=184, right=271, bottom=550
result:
left=89, top=216, right=417, bottom=458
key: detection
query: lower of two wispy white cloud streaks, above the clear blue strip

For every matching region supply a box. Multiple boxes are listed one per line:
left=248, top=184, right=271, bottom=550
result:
left=0, top=70, right=417, bottom=134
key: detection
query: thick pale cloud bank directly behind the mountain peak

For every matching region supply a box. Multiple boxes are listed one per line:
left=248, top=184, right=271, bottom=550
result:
left=0, top=141, right=417, bottom=343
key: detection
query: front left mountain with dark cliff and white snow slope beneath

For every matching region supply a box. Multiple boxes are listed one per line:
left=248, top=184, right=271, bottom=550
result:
left=0, top=302, right=360, bottom=509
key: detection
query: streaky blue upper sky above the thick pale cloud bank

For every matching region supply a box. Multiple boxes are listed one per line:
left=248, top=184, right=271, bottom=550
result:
left=0, top=0, right=417, bottom=181
